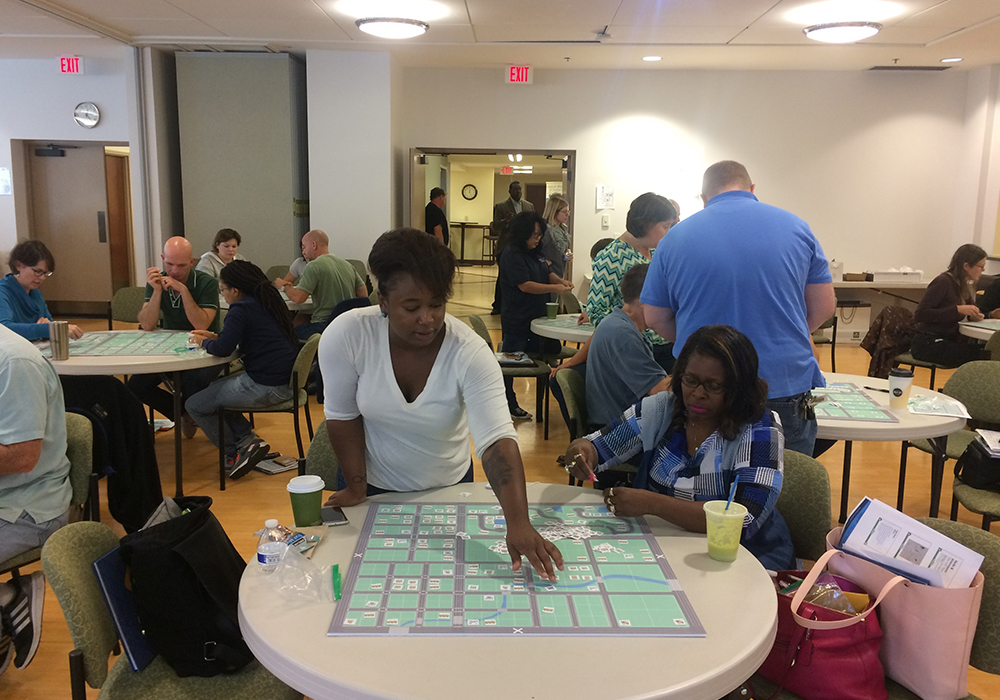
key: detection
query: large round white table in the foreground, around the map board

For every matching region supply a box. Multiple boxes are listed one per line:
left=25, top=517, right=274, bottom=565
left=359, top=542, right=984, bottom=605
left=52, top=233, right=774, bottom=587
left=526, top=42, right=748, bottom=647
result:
left=239, top=483, right=777, bottom=700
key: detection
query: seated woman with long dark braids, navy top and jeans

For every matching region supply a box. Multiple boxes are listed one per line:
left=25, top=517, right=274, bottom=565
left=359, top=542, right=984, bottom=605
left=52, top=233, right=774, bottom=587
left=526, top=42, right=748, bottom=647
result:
left=184, top=260, right=299, bottom=479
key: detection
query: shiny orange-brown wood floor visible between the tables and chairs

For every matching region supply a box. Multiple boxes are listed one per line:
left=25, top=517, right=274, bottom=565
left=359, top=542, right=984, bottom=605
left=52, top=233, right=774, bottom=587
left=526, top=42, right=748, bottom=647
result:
left=0, top=267, right=1000, bottom=700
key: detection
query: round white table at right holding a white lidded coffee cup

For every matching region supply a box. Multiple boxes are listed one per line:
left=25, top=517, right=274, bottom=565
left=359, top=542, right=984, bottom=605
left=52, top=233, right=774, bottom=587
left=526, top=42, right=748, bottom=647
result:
left=816, top=372, right=965, bottom=523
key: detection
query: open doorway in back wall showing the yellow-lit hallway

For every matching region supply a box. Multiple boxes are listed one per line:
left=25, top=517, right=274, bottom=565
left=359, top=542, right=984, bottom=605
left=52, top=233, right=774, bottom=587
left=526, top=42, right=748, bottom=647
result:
left=408, top=148, right=576, bottom=266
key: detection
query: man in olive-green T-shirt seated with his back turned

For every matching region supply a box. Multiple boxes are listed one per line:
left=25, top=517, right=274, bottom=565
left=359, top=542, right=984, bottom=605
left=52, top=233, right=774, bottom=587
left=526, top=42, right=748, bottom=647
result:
left=275, top=229, right=368, bottom=340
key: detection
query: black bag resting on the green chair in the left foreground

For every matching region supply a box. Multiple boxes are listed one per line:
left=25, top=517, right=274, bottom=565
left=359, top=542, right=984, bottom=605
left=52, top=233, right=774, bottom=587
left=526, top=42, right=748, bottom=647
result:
left=121, top=496, right=253, bottom=677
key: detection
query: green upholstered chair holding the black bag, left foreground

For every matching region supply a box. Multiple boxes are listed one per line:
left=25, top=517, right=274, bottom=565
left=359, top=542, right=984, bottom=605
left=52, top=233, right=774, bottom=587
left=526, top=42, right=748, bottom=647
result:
left=42, top=522, right=302, bottom=700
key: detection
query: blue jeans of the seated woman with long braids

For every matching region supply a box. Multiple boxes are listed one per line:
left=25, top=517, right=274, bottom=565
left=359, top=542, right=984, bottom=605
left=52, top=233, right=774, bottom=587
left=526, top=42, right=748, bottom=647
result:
left=184, top=372, right=292, bottom=455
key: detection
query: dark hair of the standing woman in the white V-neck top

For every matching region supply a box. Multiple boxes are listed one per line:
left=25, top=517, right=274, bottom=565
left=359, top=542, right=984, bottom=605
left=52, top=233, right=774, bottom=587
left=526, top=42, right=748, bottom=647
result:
left=368, top=228, right=455, bottom=300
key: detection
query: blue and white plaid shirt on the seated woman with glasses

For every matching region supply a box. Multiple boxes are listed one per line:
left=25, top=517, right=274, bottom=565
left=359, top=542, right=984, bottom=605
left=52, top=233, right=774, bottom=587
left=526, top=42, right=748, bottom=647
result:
left=587, top=402, right=785, bottom=544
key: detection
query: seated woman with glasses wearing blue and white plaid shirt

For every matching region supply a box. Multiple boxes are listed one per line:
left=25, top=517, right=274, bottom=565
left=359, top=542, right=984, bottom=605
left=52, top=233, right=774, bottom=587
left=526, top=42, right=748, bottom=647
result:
left=566, top=326, right=794, bottom=570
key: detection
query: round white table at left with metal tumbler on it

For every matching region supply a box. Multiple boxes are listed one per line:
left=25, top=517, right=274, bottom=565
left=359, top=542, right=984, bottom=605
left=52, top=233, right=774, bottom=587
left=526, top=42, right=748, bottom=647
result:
left=51, top=331, right=239, bottom=496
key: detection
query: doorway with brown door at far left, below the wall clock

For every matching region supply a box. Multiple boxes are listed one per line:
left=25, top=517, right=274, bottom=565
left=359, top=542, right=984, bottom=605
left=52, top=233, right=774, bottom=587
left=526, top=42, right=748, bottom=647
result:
left=15, top=141, right=134, bottom=315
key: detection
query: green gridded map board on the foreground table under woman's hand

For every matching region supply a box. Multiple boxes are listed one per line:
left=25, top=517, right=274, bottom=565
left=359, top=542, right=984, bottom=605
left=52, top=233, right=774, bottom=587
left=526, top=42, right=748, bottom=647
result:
left=328, top=503, right=705, bottom=637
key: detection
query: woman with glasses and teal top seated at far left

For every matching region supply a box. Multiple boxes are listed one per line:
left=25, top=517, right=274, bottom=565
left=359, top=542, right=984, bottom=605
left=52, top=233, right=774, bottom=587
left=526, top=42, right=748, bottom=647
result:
left=0, top=241, right=83, bottom=340
